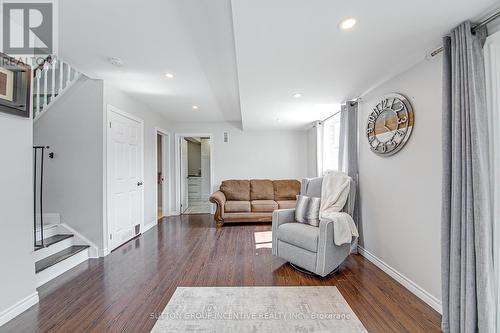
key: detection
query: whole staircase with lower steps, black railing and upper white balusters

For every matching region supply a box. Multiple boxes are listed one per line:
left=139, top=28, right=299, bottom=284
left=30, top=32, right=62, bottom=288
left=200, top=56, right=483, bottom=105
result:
left=33, top=56, right=92, bottom=287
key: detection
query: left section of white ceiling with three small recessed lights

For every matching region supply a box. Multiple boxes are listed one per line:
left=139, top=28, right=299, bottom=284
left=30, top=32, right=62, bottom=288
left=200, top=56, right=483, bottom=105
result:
left=59, top=0, right=241, bottom=121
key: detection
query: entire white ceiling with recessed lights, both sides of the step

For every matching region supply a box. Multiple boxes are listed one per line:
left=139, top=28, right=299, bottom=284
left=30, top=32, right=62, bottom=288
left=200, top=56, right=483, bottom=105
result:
left=60, top=0, right=498, bottom=130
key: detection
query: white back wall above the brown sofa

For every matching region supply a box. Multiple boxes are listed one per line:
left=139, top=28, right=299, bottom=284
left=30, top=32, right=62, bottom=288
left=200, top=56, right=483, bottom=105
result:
left=175, top=122, right=308, bottom=190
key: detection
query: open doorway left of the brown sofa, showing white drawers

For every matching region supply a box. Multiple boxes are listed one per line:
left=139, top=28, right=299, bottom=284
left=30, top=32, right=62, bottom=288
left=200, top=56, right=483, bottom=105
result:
left=177, top=135, right=213, bottom=214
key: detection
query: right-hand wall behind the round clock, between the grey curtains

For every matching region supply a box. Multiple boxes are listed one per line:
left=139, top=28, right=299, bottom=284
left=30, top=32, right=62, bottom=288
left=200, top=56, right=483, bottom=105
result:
left=359, top=58, right=441, bottom=300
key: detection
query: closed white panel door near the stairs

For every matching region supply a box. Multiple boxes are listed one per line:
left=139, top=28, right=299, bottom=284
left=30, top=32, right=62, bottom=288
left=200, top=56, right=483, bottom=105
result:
left=107, top=108, right=143, bottom=250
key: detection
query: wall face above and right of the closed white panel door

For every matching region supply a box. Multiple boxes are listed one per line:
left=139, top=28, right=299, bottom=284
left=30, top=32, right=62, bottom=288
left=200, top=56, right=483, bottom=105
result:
left=104, top=83, right=174, bottom=225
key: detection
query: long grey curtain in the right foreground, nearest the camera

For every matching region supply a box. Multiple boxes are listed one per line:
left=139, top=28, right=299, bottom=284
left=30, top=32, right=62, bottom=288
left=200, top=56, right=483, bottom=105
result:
left=441, top=22, right=495, bottom=333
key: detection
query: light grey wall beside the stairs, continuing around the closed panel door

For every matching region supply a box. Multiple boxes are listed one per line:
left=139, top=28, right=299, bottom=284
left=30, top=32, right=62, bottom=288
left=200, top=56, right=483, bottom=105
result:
left=35, top=78, right=177, bottom=253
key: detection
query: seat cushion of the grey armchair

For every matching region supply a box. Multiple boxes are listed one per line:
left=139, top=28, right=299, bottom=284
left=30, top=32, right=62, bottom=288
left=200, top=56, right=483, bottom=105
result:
left=278, top=223, right=319, bottom=252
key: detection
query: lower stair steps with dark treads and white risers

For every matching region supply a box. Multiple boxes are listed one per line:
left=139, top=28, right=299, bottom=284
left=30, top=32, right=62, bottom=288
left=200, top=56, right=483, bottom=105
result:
left=34, top=220, right=92, bottom=287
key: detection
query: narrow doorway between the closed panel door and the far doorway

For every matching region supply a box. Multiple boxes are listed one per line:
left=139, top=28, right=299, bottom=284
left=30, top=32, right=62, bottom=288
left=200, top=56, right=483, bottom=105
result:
left=155, top=128, right=171, bottom=223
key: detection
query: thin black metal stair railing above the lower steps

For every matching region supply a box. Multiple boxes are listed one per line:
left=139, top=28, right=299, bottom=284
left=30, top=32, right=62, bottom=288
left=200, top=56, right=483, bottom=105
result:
left=33, top=146, right=49, bottom=249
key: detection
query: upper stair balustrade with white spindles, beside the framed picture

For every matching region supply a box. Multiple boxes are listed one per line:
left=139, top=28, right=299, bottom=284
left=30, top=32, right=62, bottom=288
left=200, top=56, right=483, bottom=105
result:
left=33, top=55, right=81, bottom=121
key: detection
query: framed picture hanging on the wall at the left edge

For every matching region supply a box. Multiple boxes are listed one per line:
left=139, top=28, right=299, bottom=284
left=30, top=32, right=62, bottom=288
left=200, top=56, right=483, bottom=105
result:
left=0, top=53, right=31, bottom=118
